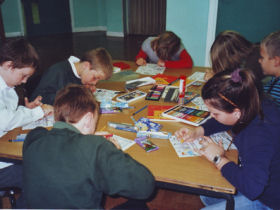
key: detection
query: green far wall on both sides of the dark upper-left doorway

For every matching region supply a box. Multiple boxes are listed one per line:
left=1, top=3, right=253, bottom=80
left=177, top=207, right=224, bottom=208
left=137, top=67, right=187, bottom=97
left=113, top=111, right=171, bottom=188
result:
left=2, top=0, right=123, bottom=36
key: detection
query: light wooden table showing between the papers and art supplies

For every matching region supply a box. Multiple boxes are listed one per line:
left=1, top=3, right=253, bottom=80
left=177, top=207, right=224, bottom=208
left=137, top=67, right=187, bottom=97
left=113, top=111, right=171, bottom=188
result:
left=0, top=62, right=237, bottom=209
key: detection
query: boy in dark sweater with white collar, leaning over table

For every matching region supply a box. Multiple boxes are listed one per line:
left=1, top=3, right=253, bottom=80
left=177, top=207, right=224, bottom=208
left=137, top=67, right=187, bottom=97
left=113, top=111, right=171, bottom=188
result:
left=31, top=48, right=113, bottom=105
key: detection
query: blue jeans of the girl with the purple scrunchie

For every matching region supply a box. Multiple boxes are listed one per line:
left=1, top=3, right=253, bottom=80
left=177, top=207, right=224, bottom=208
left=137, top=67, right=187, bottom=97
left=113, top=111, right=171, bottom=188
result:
left=200, top=192, right=271, bottom=210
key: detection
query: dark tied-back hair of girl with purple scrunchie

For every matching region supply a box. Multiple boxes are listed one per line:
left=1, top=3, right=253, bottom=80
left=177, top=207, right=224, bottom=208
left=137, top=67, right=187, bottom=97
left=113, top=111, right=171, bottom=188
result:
left=202, top=69, right=263, bottom=133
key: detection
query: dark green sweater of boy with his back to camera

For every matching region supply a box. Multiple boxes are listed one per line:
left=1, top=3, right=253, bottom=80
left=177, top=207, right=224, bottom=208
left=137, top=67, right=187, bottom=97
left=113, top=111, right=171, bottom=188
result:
left=23, top=122, right=155, bottom=209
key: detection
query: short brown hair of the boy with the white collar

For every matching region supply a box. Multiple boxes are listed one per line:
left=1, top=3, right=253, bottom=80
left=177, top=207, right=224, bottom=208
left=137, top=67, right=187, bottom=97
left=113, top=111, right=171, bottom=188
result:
left=81, top=47, right=113, bottom=79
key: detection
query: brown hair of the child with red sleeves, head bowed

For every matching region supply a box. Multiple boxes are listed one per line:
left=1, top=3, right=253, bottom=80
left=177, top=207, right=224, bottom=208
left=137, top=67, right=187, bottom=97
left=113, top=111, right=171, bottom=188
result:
left=151, top=31, right=181, bottom=60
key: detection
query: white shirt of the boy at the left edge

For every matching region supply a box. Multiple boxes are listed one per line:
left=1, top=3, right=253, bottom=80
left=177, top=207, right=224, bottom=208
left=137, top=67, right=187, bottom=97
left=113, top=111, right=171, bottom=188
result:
left=0, top=76, right=44, bottom=137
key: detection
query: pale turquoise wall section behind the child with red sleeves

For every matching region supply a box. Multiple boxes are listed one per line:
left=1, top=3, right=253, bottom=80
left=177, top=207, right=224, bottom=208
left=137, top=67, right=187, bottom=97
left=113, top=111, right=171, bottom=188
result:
left=166, top=0, right=210, bottom=66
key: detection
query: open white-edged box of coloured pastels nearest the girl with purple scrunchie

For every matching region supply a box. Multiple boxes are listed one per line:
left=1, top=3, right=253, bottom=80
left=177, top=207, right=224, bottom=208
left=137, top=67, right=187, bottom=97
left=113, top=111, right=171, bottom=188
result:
left=162, top=104, right=210, bottom=126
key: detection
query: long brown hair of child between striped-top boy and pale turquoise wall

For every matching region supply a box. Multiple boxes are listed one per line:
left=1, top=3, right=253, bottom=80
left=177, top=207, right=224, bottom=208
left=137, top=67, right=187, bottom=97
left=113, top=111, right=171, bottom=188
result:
left=210, top=31, right=253, bottom=73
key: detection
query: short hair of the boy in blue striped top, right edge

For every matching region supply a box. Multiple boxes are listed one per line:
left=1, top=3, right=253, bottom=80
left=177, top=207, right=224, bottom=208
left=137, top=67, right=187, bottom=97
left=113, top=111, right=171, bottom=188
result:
left=261, top=31, right=280, bottom=58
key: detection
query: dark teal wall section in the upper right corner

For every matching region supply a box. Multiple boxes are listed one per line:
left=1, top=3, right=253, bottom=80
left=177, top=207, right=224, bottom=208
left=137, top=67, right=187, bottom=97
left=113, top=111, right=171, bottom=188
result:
left=216, top=0, right=280, bottom=42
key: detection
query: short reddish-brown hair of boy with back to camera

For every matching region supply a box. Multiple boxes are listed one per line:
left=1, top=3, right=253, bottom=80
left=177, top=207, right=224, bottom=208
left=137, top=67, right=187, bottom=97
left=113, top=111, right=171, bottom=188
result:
left=54, top=84, right=98, bottom=123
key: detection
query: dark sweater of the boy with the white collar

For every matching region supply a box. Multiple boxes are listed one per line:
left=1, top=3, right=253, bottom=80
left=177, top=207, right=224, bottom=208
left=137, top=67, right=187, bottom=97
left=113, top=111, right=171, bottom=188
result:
left=30, top=60, right=82, bottom=105
